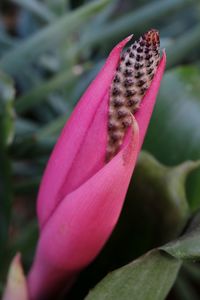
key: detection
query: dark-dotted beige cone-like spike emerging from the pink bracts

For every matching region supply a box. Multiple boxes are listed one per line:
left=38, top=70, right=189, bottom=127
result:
left=106, top=29, right=160, bottom=161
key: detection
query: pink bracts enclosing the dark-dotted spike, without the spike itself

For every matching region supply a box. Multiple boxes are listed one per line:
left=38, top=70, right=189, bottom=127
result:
left=28, top=36, right=166, bottom=300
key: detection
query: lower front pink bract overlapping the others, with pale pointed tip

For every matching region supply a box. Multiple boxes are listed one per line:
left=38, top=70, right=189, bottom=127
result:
left=29, top=121, right=139, bottom=300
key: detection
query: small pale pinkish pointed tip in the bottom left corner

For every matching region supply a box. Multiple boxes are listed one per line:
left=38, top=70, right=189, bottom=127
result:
left=2, top=254, right=28, bottom=300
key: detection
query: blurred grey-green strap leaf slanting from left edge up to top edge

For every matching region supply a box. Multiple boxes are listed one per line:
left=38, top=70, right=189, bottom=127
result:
left=0, top=0, right=109, bottom=74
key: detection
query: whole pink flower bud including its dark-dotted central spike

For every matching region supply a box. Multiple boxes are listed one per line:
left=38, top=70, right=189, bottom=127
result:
left=28, top=30, right=166, bottom=300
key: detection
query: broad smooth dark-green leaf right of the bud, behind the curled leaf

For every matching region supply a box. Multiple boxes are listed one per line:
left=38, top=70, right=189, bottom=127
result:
left=144, top=66, right=200, bottom=209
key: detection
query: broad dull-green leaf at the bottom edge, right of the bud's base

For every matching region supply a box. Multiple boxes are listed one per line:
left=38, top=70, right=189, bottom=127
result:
left=85, top=250, right=181, bottom=300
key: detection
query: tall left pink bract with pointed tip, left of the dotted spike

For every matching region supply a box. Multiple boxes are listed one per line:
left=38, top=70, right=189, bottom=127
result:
left=37, top=36, right=132, bottom=227
